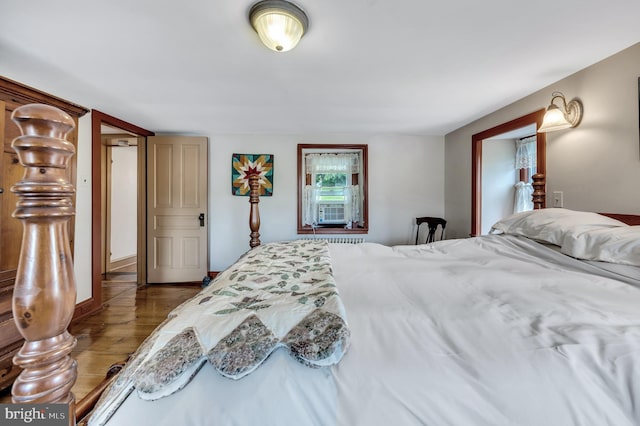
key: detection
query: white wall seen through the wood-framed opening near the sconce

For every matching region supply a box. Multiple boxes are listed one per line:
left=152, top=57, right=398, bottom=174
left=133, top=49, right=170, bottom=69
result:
left=481, top=139, right=517, bottom=234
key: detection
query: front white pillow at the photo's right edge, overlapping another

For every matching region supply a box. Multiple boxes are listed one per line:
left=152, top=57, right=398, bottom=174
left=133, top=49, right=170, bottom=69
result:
left=560, top=226, right=640, bottom=266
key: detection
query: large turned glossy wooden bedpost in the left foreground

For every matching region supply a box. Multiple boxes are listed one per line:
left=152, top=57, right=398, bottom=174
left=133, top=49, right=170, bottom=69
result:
left=11, top=104, right=77, bottom=424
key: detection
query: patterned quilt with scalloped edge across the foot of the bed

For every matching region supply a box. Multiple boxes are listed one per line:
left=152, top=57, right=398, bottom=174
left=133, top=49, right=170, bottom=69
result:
left=90, top=240, right=349, bottom=425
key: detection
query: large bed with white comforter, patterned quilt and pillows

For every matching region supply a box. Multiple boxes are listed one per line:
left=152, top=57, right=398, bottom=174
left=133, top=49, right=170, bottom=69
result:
left=8, top=104, right=640, bottom=426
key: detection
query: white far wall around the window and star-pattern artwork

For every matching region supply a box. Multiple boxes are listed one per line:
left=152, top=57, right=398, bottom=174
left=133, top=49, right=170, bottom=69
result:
left=209, top=134, right=444, bottom=271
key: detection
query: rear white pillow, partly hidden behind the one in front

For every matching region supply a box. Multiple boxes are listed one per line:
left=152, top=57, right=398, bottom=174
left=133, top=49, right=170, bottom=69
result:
left=491, top=208, right=628, bottom=246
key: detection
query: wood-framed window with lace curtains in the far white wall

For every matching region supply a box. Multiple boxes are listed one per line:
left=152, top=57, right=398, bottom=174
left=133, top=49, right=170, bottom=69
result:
left=298, top=144, right=368, bottom=234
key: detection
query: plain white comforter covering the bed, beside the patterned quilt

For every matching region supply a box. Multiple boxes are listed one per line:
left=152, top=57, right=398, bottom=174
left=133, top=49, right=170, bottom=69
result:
left=99, top=236, right=640, bottom=426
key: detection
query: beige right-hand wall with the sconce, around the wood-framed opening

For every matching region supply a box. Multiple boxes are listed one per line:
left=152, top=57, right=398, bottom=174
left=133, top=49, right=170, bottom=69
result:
left=445, top=44, right=640, bottom=238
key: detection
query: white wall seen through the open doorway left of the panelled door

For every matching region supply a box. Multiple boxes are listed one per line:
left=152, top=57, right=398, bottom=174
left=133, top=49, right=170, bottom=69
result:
left=110, top=146, right=138, bottom=262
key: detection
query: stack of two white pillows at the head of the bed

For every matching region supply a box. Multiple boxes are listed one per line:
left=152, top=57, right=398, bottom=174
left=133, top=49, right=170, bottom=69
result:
left=491, top=208, right=640, bottom=266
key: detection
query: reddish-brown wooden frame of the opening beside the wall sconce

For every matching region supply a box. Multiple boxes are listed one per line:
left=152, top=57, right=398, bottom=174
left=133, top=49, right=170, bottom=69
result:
left=471, top=108, right=547, bottom=236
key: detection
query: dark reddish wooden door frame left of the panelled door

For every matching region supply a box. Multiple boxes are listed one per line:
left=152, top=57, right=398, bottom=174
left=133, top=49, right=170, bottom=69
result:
left=91, top=109, right=155, bottom=310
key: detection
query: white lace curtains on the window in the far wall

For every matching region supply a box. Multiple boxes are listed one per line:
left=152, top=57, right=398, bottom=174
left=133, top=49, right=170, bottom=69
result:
left=303, top=152, right=360, bottom=227
